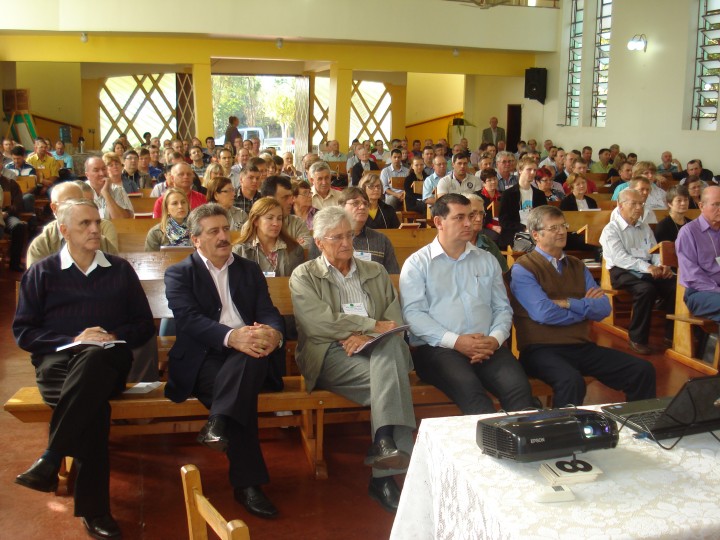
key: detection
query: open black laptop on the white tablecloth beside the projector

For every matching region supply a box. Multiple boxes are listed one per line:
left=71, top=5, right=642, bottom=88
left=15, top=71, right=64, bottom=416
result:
left=602, top=376, right=720, bottom=440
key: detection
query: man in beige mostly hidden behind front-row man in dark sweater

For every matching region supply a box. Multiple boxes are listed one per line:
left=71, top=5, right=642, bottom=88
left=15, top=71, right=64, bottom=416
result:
left=27, top=182, right=118, bottom=268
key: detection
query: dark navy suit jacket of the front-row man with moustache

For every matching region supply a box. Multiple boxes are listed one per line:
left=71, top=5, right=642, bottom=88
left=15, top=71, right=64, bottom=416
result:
left=165, top=252, right=284, bottom=403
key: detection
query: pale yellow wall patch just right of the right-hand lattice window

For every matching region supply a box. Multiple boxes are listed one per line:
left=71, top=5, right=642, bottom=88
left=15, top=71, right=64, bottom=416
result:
left=405, top=73, right=465, bottom=125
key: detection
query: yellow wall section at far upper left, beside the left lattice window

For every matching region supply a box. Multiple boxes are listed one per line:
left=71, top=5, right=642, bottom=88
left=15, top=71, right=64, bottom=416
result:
left=15, top=62, right=82, bottom=125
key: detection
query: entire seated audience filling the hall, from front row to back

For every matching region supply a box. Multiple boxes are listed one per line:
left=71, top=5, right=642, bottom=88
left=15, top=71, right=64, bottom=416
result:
left=7, top=122, right=720, bottom=538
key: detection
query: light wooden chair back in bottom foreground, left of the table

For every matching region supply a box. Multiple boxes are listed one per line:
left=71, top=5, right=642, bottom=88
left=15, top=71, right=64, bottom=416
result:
left=180, top=465, right=250, bottom=540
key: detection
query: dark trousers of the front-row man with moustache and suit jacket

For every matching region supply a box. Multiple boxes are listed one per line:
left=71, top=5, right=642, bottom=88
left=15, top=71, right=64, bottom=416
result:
left=193, top=349, right=276, bottom=488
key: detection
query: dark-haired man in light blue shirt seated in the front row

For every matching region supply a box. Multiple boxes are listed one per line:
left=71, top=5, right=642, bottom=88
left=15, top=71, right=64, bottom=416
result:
left=400, top=193, right=535, bottom=414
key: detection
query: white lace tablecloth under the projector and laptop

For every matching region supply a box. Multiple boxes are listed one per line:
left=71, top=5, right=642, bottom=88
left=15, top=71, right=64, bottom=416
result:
left=390, top=410, right=720, bottom=540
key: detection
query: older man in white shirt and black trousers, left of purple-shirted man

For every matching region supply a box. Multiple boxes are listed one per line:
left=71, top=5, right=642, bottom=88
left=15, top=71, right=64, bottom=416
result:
left=600, top=187, right=675, bottom=354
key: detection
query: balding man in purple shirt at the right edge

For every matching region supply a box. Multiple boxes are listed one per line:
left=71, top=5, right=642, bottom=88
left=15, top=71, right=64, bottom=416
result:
left=675, top=186, right=720, bottom=323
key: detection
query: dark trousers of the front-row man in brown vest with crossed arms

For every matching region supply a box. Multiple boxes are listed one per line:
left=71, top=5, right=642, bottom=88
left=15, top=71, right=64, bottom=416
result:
left=520, top=343, right=655, bottom=407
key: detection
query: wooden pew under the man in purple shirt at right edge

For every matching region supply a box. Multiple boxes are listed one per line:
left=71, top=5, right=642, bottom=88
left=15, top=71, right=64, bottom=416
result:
left=656, top=242, right=720, bottom=375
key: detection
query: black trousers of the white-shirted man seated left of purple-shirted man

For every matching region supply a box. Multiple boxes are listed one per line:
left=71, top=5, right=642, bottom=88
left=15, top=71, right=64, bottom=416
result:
left=610, top=266, right=675, bottom=345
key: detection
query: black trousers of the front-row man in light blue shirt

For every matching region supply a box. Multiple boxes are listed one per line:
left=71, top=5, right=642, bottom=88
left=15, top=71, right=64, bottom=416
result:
left=413, top=345, right=535, bottom=414
